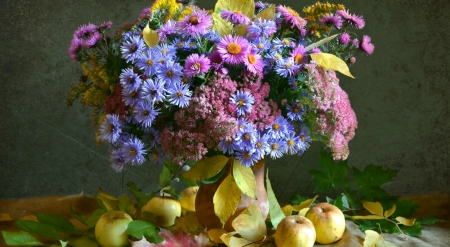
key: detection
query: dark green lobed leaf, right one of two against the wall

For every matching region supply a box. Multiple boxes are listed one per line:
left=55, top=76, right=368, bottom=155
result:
left=353, top=164, right=398, bottom=201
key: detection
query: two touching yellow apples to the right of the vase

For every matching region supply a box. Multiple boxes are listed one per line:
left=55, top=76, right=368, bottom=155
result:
left=275, top=202, right=345, bottom=247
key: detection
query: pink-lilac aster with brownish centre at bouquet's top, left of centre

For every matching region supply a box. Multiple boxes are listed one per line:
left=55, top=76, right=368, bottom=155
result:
left=178, top=10, right=213, bottom=37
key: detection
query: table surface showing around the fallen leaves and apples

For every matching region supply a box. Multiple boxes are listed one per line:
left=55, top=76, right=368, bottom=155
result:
left=0, top=194, right=450, bottom=247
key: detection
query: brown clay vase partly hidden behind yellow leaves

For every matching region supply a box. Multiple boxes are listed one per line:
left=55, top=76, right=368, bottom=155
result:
left=195, top=159, right=269, bottom=232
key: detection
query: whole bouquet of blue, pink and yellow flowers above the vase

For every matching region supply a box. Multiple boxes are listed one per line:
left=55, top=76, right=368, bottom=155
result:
left=67, top=0, right=374, bottom=171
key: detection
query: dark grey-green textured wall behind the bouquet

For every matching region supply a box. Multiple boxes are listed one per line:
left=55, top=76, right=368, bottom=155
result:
left=0, top=0, right=450, bottom=203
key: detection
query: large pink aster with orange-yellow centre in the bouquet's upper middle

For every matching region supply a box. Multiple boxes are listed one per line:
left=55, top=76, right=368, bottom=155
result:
left=217, top=35, right=250, bottom=64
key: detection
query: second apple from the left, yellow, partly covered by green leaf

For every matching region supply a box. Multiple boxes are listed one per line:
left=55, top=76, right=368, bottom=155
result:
left=141, top=196, right=181, bottom=227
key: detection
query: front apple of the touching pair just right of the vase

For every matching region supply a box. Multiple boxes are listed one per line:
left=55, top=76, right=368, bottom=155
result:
left=275, top=215, right=316, bottom=247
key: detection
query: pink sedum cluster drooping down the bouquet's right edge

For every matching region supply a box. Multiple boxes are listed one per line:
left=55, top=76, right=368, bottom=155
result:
left=305, top=62, right=358, bottom=160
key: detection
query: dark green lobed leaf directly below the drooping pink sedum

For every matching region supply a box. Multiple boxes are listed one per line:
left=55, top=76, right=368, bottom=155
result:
left=308, top=150, right=350, bottom=192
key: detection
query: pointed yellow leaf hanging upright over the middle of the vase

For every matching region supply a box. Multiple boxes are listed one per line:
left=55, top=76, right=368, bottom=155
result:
left=213, top=174, right=242, bottom=225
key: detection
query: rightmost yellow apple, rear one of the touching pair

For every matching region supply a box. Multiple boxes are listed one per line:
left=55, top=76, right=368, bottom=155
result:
left=305, top=202, right=345, bottom=244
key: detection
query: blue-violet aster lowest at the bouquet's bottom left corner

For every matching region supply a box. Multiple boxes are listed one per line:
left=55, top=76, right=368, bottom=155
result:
left=119, top=136, right=147, bottom=165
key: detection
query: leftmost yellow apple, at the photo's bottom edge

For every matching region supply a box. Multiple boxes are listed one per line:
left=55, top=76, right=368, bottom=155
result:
left=95, top=210, right=133, bottom=247
